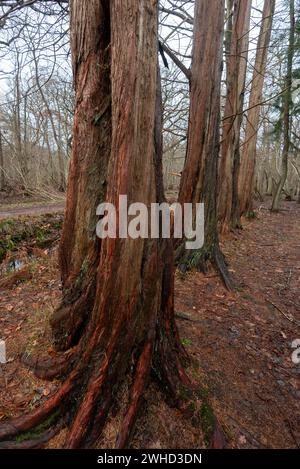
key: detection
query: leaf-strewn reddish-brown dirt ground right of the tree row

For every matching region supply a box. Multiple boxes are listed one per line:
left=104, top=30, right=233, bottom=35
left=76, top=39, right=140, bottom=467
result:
left=176, top=197, right=300, bottom=448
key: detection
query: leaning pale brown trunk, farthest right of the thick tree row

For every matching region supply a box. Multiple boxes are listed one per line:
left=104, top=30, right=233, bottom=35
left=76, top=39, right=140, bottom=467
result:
left=239, top=0, right=276, bottom=215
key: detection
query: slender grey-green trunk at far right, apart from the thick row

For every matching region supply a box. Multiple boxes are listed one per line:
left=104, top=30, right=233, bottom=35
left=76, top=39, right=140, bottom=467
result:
left=271, top=0, right=295, bottom=212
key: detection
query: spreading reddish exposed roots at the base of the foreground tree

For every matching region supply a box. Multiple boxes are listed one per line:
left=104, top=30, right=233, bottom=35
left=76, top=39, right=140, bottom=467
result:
left=0, top=284, right=224, bottom=448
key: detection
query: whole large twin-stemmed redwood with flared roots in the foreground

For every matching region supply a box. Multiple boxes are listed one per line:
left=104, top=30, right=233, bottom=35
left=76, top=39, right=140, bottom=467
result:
left=0, top=0, right=190, bottom=448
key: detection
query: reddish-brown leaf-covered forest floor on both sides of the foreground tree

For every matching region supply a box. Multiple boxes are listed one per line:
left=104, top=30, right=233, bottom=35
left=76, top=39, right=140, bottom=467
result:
left=0, top=196, right=300, bottom=448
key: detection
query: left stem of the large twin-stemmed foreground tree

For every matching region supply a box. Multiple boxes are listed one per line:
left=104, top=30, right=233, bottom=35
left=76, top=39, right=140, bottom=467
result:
left=51, top=0, right=112, bottom=350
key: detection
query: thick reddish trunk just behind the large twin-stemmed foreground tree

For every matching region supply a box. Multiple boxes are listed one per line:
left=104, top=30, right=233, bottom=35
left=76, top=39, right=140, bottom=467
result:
left=176, top=0, right=230, bottom=287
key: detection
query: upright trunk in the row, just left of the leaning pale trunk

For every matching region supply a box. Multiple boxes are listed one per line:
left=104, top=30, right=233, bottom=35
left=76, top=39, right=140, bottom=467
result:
left=218, top=0, right=251, bottom=232
